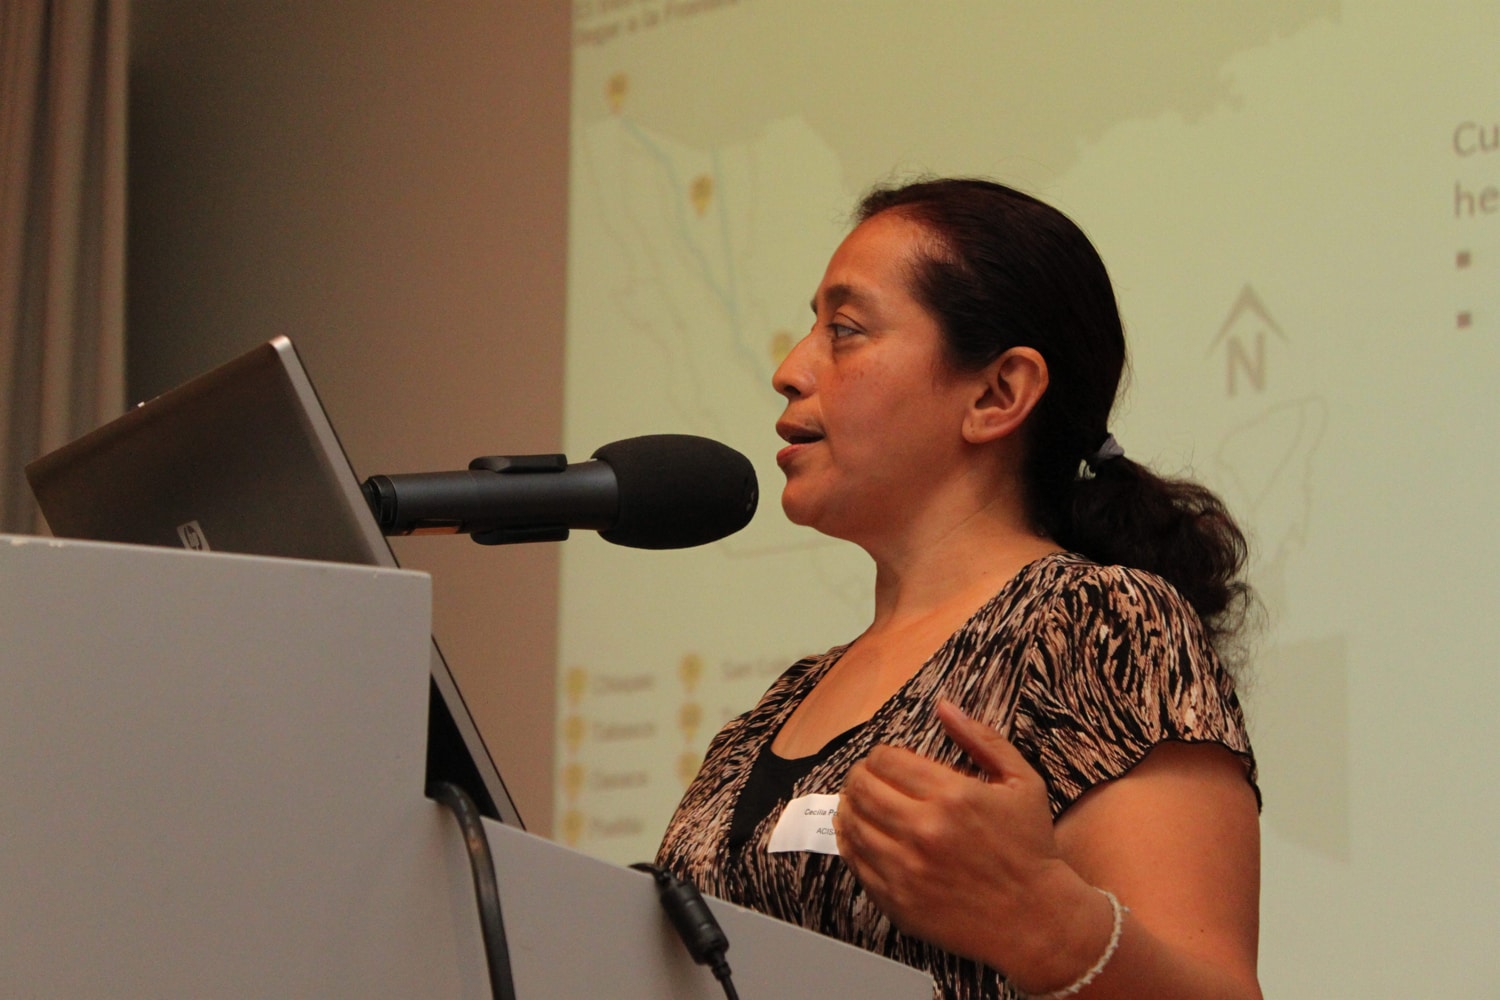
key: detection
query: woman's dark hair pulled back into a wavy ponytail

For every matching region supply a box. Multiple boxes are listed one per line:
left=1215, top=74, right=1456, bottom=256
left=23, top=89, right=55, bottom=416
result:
left=857, top=178, right=1253, bottom=654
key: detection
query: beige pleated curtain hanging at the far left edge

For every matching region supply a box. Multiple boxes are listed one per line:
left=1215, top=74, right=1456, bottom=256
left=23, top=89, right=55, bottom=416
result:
left=0, top=0, right=128, bottom=534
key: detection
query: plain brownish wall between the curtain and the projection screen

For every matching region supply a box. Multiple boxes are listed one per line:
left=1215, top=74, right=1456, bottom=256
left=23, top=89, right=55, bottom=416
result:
left=126, top=0, right=570, bottom=834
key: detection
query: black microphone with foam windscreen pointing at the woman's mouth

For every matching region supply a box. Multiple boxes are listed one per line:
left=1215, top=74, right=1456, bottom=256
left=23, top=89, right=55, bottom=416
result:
left=362, top=435, right=759, bottom=549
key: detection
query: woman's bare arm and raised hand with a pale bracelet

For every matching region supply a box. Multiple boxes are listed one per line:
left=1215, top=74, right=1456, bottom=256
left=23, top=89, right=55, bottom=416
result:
left=837, top=705, right=1260, bottom=1000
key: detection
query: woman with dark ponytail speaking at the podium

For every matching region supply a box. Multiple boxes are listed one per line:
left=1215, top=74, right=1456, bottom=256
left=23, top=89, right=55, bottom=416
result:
left=657, top=180, right=1260, bottom=1000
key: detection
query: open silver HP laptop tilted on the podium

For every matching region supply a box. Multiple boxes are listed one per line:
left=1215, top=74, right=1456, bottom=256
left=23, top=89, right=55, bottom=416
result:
left=26, top=337, right=522, bottom=826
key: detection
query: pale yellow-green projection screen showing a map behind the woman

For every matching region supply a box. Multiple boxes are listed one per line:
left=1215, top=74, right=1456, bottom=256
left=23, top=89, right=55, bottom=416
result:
left=555, top=0, right=1500, bottom=997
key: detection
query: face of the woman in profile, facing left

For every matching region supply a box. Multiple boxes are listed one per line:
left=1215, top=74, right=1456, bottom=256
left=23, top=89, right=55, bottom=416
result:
left=771, top=211, right=981, bottom=543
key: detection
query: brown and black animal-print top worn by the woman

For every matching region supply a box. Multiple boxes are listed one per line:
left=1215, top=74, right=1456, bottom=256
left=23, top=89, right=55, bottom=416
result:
left=657, top=553, right=1259, bottom=1000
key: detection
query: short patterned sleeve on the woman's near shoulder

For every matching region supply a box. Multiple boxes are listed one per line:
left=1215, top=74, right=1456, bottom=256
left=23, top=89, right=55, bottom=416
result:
left=1014, top=565, right=1260, bottom=816
